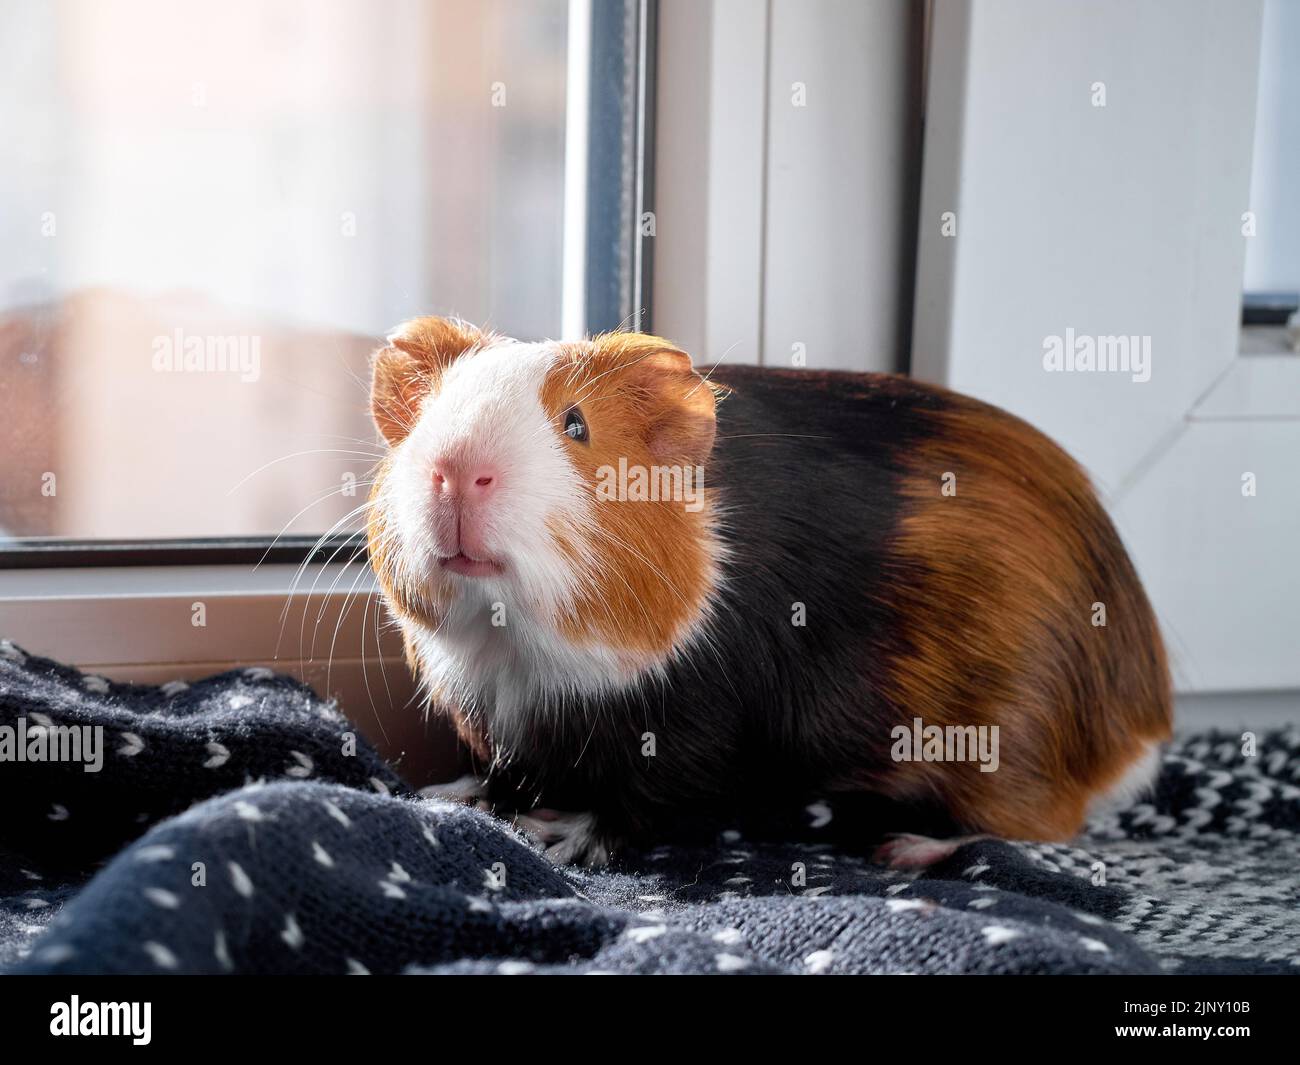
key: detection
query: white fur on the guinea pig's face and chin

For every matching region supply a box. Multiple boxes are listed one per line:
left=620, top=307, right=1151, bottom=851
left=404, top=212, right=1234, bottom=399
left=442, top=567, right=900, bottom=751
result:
left=377, top=339, right=716, bottom=748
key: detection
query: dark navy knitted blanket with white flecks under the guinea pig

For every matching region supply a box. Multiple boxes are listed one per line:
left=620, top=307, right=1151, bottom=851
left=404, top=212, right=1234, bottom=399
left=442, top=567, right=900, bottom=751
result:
left=0, top=642, right=1300, bottom=974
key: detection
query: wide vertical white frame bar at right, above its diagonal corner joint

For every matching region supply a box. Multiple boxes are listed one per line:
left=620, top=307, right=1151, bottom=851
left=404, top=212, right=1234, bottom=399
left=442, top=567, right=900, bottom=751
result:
left=913, top=0, right=1260, bottom=492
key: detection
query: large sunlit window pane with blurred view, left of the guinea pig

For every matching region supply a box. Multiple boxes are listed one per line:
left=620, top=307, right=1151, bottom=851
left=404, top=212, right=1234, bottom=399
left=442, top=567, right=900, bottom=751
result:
left=0, top=0, right=653, bottom=564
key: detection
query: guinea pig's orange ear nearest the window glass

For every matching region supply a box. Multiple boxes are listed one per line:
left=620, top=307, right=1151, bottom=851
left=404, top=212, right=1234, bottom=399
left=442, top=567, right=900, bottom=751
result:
left=371, top=316, right=486, bottom=443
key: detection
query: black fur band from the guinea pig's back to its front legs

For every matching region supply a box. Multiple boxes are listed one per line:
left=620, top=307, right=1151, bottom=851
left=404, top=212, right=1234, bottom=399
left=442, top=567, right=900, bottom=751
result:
left=491, top=368, right=948, bottom=840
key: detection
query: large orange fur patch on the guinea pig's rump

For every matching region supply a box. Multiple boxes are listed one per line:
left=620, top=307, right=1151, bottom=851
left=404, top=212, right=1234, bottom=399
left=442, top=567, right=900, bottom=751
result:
left=885, top=399, right=1171, bottom=839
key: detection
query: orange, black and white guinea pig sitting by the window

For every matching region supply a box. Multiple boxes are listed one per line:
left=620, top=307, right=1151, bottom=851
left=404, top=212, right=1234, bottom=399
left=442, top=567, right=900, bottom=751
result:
left=367, top=317, right=1171, bottom=865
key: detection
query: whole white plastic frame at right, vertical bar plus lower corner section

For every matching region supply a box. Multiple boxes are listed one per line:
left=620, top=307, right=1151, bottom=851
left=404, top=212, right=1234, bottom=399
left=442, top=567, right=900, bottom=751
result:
left=913, top=0, right=1300, bottom=692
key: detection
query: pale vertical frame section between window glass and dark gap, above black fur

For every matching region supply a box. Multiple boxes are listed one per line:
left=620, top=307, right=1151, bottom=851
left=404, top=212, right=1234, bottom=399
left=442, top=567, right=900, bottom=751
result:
left=654, top=0, right=919, bottom=369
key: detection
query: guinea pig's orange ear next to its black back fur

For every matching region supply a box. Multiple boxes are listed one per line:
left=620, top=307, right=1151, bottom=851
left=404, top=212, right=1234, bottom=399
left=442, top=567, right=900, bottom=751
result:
left=628, top=347, right=723, bottom=466
